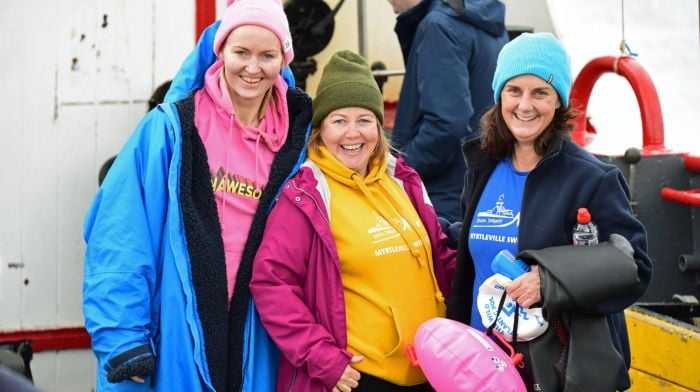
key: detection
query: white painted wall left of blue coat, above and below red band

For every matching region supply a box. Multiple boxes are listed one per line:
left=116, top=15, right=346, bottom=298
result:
left=0, top=0, right=194, bottom=391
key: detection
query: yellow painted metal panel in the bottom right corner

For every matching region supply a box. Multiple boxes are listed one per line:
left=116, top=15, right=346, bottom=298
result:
left=625, top=308, right=700, bottom=391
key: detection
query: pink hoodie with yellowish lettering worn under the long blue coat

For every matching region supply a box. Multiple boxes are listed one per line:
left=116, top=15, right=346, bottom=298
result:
left=194, top=60, right=289, bottom=300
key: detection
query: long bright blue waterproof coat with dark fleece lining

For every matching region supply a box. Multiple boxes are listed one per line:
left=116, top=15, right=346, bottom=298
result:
left=83, top=22, right=311, bottom=391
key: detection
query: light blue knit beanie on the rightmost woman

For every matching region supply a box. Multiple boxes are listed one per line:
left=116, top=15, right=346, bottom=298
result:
left=491, top=33, right=571, bottom=107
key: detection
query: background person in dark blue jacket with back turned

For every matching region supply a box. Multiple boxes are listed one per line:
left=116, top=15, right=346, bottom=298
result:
left=389, top=0, right=508, bottom=222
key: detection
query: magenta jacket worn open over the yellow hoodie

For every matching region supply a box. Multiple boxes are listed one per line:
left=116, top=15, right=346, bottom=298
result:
left=250, top=156, right=455, bottom=392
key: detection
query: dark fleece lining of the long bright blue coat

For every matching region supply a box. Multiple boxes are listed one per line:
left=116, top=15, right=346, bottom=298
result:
left=177, top=89, right=311, bottom=391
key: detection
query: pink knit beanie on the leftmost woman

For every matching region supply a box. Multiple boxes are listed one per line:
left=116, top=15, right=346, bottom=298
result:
left=214, top=0, right=294, bottom=65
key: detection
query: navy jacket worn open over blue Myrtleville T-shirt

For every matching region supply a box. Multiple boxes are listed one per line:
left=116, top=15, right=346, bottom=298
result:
left=447, top=138, right=652, bottom=390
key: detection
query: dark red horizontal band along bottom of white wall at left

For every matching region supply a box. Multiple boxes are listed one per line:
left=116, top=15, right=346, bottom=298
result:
left=0, top=327, right=91, bottom=352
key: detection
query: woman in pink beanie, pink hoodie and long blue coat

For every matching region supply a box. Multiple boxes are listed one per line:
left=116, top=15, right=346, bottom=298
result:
left=83, top=0, right=311, bottom=391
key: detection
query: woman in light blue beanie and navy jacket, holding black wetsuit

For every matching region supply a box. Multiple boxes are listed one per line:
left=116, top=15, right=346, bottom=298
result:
left=447, top=33, right=652, bottom=391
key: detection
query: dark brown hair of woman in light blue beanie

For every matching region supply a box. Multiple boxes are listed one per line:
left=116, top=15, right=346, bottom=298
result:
left=480, top=100, right=579, bottom=158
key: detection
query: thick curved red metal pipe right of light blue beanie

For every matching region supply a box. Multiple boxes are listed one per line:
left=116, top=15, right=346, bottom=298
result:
left=571, top=56, right=668, bottom=155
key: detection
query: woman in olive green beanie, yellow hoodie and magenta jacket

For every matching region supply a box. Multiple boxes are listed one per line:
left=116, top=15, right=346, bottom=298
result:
left=250, top=51, right=455, bottom=392
